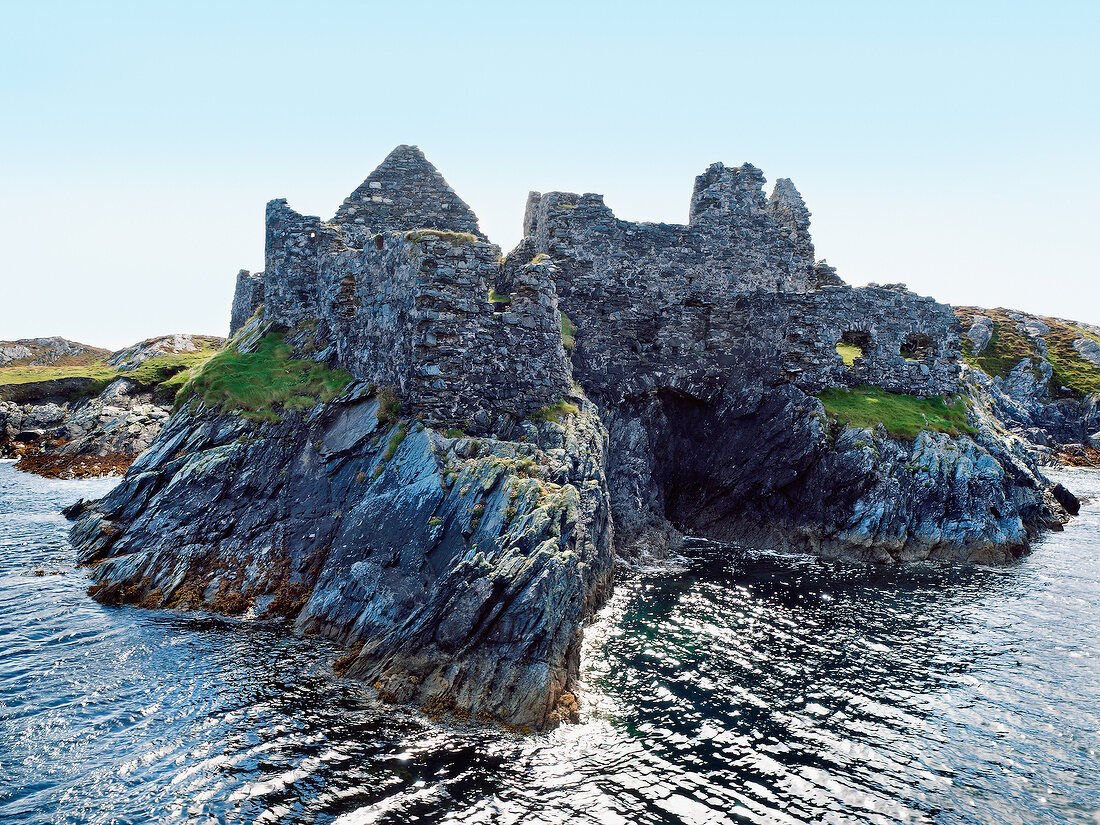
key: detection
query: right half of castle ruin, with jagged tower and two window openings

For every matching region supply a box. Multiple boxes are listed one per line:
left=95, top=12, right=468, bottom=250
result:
left=505, top=164, right=959, bottom=402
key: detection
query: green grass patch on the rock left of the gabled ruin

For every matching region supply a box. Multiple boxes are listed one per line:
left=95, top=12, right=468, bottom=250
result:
left=177, top=332, right=351, bottom=421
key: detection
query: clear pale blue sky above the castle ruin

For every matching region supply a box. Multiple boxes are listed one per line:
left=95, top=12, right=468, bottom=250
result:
left=0, top=0, right=1100, bottom=348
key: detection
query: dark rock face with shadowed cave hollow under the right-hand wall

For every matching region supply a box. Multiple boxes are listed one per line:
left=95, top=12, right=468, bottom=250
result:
left=605, top=371, right=1065, bottom=563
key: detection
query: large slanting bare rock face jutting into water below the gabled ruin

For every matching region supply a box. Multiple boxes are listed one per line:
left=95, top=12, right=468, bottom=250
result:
left=73, top=354, right=612, bottom=728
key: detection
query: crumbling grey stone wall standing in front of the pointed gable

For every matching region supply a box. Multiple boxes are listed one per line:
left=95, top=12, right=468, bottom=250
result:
left=256, top=200, right=572, bottom=421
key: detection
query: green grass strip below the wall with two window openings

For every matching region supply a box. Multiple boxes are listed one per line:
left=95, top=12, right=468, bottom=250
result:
left=817, top=386, right=976, bottom=441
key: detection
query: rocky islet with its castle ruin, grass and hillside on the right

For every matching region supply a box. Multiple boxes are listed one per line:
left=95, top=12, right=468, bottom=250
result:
left=62, top=146, right=1100, bottom=729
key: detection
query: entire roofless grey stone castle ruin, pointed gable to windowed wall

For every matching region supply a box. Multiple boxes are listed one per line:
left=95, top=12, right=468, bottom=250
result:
left=232, top=146, right=961, bottom=421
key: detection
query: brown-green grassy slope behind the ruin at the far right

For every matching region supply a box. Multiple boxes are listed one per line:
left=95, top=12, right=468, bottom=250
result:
left=955, top=307, right=1100, bottom=395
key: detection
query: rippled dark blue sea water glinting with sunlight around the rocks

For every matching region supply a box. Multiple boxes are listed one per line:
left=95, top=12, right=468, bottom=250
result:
left=0, top=462, right=1100, bottom=824
